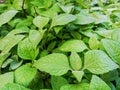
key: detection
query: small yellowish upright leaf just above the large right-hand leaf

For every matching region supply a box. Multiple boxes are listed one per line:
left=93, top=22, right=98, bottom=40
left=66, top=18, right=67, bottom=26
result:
left=89, top=36, right=99, bottom=49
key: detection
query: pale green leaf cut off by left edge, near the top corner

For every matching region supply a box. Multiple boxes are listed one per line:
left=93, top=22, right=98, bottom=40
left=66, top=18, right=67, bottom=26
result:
left=0, top=10, right=18, bottom=27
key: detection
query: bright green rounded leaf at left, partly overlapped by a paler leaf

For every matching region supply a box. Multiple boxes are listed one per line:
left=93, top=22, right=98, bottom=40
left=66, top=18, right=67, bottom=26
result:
left=17, top=38, right=39, bottom=60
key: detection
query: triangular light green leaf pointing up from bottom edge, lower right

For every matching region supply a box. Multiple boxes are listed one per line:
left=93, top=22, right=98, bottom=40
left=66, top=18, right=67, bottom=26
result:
left=89, top=75, right=111, bottom=90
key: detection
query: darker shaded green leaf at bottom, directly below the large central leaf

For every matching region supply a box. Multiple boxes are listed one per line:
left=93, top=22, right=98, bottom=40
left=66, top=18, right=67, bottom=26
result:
left=51, top=76, right=68, bottom=90
